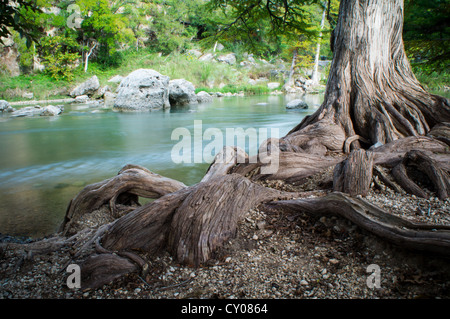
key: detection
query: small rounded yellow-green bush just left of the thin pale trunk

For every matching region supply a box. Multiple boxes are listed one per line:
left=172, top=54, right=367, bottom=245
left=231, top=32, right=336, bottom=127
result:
left=39, top=35, right=80, bottom=81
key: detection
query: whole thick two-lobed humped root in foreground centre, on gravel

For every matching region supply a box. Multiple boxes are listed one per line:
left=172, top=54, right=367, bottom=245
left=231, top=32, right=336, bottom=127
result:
left=101, top=174, right=294, bottom=265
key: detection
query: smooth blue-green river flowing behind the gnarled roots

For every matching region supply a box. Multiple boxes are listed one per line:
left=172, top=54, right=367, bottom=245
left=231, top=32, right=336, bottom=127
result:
left=0, top=95, right=323, bottom=238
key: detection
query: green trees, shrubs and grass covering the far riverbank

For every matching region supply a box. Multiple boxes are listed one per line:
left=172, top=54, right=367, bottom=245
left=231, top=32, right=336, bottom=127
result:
left=0, top=0, right=449, bottom=101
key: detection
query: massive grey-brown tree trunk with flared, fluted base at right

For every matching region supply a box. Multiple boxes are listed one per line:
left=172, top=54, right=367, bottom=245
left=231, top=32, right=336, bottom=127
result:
left=286, top=0, right=450, bottom=151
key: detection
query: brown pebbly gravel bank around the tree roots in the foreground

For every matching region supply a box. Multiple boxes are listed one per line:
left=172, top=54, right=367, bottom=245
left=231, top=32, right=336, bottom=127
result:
left=0, top=185, right=450, bottom=299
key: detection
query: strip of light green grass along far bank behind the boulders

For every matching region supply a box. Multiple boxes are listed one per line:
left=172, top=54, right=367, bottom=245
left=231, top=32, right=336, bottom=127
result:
left=0, top=50, right=280, bottom=101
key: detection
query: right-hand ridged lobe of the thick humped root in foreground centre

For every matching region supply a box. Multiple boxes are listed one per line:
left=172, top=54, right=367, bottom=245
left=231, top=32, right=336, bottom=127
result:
left=168, top=174, right=293, bottom=266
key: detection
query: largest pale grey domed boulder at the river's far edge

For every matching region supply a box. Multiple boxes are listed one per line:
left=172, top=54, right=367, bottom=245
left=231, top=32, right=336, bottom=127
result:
left=114, top=69, right=170, bottom=111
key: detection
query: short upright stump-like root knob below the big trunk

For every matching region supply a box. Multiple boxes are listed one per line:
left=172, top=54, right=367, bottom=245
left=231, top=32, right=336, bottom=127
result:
left=333, top=149, right=373, bottom=196
